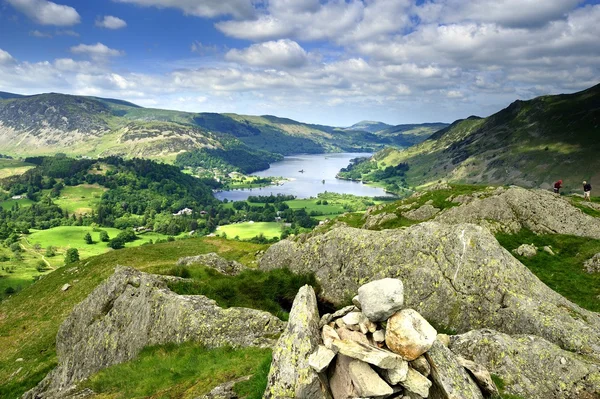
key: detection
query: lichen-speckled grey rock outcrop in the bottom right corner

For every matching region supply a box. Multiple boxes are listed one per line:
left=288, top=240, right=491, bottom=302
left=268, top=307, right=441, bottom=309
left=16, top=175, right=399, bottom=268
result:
left=450, top=329, right=600, bottom=399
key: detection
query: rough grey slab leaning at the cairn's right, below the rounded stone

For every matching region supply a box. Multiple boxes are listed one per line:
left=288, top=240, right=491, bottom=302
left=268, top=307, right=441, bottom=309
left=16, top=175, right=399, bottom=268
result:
left=425, top=341, right=483, bottom=399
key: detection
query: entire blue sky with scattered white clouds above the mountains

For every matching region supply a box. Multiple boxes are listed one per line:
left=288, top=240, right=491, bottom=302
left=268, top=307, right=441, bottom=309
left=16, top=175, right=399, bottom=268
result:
left=0, top=0, right=600, bottom=126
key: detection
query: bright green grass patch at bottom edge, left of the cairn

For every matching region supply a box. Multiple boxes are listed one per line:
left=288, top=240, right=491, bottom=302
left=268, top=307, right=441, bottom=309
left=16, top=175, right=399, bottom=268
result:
left=81, top=343, right=271, bottom=399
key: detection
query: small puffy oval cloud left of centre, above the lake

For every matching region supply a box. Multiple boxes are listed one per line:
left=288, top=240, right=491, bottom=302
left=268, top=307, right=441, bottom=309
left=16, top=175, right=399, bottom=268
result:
left=225, top=39, right=308, bottom=68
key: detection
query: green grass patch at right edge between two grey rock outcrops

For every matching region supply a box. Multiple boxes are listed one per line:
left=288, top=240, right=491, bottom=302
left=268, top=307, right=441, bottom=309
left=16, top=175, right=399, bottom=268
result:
left=496, top=230, right=600, bottom=312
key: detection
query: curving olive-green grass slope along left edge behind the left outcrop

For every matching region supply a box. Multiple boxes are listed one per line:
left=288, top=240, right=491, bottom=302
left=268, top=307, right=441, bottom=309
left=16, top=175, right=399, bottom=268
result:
left=0, top=238, right=267, bottom=398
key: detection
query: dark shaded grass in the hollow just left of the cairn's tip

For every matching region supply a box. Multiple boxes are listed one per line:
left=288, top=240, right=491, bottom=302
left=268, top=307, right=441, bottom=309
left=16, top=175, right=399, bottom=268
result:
left=167, top=267, right=319, bottom=320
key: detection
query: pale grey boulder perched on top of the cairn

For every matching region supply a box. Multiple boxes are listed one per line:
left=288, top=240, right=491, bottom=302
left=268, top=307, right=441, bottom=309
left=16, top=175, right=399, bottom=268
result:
left=358, top=278, right=404, bottom=322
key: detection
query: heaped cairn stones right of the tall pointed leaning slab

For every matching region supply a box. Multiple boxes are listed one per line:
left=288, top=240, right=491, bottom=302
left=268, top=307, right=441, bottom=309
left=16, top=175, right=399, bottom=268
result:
left=308, top=278, right=497, bottom=399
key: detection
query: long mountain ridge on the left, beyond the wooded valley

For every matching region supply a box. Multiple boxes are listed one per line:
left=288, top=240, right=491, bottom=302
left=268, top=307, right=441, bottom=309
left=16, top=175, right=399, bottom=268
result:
left=0, top=93, right=412, bottom=162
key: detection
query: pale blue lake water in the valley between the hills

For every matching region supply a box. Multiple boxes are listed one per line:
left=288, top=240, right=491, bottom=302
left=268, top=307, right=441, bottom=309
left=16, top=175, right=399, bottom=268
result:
left=215, top=153, right=387, bottom=201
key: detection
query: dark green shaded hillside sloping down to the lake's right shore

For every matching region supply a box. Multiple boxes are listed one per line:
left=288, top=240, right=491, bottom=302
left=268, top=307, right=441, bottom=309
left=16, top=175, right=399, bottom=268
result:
left=352, top=85, right=600, bottom=190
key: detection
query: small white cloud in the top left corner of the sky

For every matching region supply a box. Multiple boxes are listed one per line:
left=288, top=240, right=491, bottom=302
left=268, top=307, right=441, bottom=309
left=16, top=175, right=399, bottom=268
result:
left=6, top=0, right=81, bottom=26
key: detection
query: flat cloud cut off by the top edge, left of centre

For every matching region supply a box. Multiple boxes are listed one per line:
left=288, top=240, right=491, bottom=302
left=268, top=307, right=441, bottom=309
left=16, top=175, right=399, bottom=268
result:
left=113, top=0, right=254, bottom=18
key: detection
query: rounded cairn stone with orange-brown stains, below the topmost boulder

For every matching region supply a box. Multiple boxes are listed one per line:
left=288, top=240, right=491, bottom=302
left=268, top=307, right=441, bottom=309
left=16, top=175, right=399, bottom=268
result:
left=385, top=309, right=437, bottom=361
